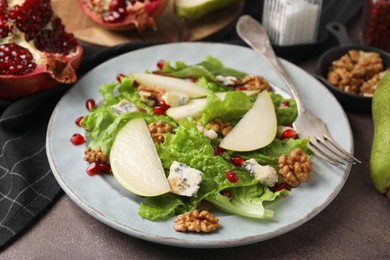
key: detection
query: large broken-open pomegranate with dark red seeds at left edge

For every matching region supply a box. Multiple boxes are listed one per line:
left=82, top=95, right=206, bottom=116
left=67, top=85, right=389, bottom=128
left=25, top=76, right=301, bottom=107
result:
left=0, top=0, right=83, bottom=100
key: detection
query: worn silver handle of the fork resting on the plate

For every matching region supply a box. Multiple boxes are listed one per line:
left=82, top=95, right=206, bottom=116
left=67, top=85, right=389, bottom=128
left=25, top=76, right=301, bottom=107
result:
left=236, top=15, right=306, bottom=112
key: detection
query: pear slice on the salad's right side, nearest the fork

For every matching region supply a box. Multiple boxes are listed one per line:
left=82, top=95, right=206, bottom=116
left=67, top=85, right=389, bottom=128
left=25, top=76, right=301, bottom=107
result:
left=219, top=91, right=277, bottom=152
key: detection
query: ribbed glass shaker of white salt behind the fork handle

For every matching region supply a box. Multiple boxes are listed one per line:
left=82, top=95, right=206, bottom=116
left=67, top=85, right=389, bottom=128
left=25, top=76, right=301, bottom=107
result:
left=262, top=0, right=322, bottom=46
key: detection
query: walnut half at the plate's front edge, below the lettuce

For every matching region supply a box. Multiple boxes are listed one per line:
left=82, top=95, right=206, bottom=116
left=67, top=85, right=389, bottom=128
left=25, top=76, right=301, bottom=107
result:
left=173, top=209, right=219, bottom=233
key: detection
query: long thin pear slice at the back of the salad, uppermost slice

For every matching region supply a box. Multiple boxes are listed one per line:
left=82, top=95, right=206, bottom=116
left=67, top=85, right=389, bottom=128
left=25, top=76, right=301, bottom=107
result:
left=132, top=73, right=210, bottom=98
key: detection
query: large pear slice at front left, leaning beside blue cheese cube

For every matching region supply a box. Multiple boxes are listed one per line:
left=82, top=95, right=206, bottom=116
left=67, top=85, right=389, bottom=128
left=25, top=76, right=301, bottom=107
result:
left=110, top=118, right=170, bottom=196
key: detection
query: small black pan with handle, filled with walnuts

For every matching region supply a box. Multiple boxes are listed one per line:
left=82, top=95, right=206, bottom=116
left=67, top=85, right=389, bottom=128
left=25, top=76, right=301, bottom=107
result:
left=315, top=23, right=390, bottom=112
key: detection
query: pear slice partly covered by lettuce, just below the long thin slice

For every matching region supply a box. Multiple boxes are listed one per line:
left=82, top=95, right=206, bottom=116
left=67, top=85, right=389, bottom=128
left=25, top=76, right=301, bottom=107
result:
left=167, top=90, right=259, bottom=121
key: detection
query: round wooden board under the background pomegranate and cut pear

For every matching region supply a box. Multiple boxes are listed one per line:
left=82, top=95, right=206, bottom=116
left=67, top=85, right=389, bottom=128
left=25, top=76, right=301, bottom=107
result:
left=52, top=0, right=244, bottom=47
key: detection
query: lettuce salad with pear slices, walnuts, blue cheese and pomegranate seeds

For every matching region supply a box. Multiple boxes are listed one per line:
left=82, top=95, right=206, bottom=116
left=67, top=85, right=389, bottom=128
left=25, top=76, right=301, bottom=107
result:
left=70, top=56, right=313, bottom=232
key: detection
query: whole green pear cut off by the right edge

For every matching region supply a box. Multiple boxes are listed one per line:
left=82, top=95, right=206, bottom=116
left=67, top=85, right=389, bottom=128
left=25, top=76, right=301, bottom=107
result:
left=370, top=70, right=390, bottom=199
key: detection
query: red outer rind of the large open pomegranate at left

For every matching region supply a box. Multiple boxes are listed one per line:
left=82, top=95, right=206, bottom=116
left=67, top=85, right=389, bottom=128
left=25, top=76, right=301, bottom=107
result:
left=0, top=46, right=83, bottom=101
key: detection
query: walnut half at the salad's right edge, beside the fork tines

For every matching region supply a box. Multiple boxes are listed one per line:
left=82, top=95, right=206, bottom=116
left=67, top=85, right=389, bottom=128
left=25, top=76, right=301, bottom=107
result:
left=278, top=148, right=313, bottom=188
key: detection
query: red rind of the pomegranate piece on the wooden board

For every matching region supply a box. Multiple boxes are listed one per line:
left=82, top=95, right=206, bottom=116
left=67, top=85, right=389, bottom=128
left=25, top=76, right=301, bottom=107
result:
left=79, top=0, right=170, bottom=33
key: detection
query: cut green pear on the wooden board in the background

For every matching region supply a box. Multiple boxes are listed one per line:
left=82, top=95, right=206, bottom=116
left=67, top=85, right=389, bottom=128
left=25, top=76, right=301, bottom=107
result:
left=173, top=0, right=241, bottom=20
